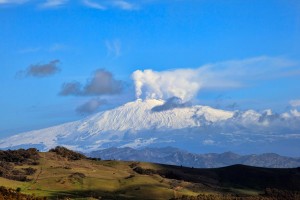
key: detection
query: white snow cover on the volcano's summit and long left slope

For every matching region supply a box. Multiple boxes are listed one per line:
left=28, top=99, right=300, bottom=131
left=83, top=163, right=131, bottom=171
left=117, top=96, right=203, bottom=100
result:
left=0, top=99, right=233, bottom=150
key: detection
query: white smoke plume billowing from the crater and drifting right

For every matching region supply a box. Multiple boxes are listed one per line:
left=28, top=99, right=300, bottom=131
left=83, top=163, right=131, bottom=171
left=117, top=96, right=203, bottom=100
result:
left=132, top=56, right=297, bottom=101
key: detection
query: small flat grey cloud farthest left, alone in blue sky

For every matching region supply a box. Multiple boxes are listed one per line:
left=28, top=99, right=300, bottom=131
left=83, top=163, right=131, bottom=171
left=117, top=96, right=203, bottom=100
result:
left=16, top=60, right=60, bottom=78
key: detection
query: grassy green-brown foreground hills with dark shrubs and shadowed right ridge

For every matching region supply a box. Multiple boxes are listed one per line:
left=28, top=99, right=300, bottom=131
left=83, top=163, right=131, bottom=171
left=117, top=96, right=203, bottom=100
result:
left=0, top=150, right=300, bottom=199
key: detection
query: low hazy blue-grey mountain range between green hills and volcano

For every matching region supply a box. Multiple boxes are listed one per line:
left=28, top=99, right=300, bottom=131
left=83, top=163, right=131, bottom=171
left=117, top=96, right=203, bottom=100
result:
left=88, top=147, right=300, bottom=168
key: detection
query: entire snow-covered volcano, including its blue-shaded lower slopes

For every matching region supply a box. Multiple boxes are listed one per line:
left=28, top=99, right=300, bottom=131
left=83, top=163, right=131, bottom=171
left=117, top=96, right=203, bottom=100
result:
left=0, top=99, right=299, bottom=155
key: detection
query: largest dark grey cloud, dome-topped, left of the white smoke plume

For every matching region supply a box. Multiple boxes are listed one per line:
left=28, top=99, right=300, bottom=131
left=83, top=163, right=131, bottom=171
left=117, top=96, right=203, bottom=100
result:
left=59, top=69, right=123, bottom=96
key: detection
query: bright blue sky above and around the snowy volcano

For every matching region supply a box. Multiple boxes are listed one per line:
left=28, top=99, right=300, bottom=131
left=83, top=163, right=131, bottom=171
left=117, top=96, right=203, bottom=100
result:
left=0, top=0, right=300, bottom=137
